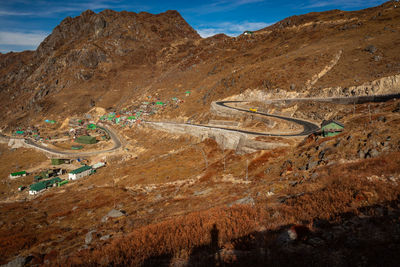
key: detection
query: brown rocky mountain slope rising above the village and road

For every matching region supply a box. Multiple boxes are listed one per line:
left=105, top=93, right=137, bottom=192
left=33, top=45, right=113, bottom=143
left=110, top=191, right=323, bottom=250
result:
left=0, top=2, right=400, bottom=130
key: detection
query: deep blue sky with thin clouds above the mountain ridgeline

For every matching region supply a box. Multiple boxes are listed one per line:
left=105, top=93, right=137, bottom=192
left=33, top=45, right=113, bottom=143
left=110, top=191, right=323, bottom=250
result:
left=0, top=0, right=385, bottom=53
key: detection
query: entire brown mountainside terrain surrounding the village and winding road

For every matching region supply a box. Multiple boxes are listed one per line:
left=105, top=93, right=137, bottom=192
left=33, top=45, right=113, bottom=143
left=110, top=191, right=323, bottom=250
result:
left=0, top=2, right=400, bottom=266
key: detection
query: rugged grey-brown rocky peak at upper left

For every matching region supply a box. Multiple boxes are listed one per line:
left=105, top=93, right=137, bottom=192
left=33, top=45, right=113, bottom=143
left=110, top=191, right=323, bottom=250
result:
left=0, top=10, right=200, bottom=127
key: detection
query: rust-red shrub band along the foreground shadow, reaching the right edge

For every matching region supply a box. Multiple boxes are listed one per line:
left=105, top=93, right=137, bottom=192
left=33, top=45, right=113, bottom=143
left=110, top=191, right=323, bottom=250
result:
left=64, top=154, right=400, bottom=265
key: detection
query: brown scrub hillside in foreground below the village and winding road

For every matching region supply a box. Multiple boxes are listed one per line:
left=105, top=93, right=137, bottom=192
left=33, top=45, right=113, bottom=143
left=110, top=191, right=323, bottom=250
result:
left=0, top=101, right=400, bottom=265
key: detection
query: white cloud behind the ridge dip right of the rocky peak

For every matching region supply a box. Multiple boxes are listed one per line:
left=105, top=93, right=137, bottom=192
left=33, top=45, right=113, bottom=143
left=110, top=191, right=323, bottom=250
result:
left=197, top=21, right=272, bottom=38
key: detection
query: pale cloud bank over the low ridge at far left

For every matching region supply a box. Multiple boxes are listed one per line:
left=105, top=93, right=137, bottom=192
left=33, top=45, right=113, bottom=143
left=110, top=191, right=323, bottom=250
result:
left=0, top=31, right=48, bottom=47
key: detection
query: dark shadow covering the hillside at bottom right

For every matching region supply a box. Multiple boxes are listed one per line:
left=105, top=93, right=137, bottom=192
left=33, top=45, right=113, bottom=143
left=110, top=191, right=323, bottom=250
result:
left=185, top=198, right=400, bottom=266
